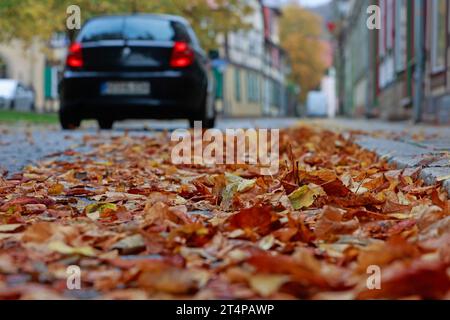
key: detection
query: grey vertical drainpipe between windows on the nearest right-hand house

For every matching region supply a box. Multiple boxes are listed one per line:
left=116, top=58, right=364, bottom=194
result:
left=414, top=0, right=425, bottom=123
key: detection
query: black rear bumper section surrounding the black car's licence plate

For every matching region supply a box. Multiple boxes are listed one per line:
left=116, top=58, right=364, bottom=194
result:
left=60, top=71, right=207, bottom=120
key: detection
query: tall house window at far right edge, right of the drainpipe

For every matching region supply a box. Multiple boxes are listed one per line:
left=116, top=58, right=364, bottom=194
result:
left=431, top=0, right=447, bottom=72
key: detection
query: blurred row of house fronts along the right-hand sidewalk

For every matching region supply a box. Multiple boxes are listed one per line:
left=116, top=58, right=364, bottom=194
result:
left=333, top=0, right=450, bottom=124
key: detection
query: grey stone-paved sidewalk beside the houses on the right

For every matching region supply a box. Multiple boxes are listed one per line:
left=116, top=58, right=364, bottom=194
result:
left=316, top=119, right=450, bottom=195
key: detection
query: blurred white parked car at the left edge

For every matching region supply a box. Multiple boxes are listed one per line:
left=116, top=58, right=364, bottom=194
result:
left=0, top=79, right=34, bottom=111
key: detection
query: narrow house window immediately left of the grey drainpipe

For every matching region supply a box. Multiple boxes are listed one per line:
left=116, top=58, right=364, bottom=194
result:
left=395, top=0, right=408, bottom=71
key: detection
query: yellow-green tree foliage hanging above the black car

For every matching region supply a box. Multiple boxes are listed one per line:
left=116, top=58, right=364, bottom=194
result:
left=0, top=0, right=252, bottom=49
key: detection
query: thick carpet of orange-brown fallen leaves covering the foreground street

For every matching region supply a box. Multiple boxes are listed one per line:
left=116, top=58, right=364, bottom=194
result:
left=0, top=125, right=450, bottom=299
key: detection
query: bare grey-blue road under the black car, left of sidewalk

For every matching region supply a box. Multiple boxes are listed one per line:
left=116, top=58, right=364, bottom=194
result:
left=0, top=118, right=298, bottom=174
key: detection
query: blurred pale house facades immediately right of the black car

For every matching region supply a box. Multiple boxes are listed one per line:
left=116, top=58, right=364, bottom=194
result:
left=218, top=0, right=288, bottom=117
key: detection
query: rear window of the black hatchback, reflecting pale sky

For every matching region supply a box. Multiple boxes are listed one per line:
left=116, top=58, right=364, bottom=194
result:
left=79, top=16, right=190, bottom=42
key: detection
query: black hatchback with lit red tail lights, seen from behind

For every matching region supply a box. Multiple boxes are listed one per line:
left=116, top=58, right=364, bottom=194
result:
left=59, top=14, right=215, bottom=129
